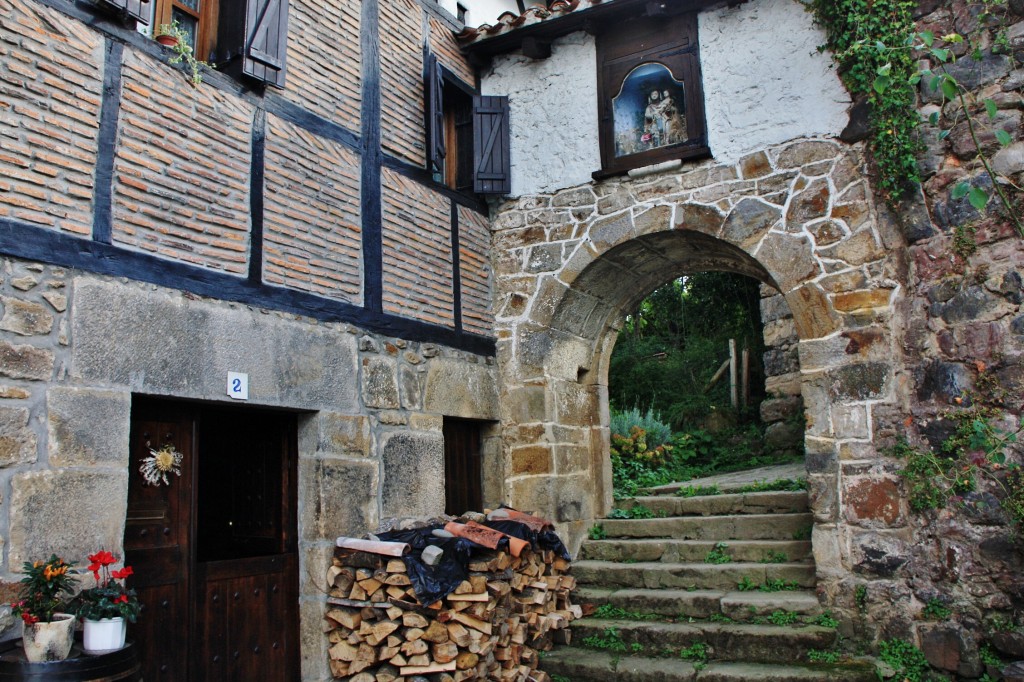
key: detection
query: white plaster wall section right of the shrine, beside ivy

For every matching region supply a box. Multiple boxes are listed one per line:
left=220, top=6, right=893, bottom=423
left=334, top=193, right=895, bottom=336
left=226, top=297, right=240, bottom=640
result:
left=697, top=0, right=850, bottom=163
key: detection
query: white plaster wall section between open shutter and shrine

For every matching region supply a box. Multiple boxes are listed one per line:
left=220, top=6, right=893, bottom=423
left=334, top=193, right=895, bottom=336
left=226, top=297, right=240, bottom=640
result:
left=480, top=33, right=601, bottom=197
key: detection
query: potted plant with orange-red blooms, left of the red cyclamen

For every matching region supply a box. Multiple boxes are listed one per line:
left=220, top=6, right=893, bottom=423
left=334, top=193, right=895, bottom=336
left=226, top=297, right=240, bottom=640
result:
left=11, top=554, right=75, bottom=663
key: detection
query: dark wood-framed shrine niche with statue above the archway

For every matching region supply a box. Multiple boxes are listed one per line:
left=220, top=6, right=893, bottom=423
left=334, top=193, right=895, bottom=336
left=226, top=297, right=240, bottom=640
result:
left=595, top=13, right=710, bottom=177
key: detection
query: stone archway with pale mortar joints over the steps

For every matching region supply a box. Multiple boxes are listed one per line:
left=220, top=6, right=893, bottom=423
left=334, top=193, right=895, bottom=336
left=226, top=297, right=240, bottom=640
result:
left=495, top=140, right=902, bottom=579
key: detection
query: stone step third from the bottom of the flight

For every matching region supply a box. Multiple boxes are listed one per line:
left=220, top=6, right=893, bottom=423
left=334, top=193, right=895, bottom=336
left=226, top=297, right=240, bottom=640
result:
left=572, top=587, right=821, bottom=623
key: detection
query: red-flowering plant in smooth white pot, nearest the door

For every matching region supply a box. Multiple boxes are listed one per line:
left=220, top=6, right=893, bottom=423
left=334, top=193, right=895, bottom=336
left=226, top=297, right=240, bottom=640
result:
left=72, top=551, right=141, bottom=653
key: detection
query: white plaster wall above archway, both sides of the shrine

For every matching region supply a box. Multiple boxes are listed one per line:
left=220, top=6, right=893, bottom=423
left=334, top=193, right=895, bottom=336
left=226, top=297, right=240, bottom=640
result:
left=480, top=0, right=850, bottom=197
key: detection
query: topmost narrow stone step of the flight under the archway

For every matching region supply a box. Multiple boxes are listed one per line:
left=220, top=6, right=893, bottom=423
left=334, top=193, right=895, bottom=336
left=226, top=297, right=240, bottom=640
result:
left=615, top=491, right=807, bottom=516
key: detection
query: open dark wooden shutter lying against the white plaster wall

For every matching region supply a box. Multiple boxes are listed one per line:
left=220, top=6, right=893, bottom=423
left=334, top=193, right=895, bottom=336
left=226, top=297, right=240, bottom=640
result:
left=473, top=95, right=512, bottom=195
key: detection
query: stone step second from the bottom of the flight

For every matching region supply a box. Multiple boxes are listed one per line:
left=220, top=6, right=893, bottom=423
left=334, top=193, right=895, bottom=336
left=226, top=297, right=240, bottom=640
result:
left=569, top=619, right=838, bottom=664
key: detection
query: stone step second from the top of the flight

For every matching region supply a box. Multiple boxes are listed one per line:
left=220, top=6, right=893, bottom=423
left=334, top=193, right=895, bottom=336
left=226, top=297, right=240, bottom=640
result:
left=600, top=514, right=814, bottom=542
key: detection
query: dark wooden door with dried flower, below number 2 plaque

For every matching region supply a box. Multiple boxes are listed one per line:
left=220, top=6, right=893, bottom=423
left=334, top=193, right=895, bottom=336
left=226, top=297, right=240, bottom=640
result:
left=125, top=401, right=299, bottom=682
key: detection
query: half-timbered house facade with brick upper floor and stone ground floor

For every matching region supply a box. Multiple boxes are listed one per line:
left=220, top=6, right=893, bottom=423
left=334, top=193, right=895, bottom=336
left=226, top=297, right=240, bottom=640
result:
left=0, top=0, right=507, bottom=682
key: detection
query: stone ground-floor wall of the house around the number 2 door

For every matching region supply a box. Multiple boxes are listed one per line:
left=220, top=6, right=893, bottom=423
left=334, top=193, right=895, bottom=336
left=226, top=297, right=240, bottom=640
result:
left=0, top=259, right=500, bottom=680
